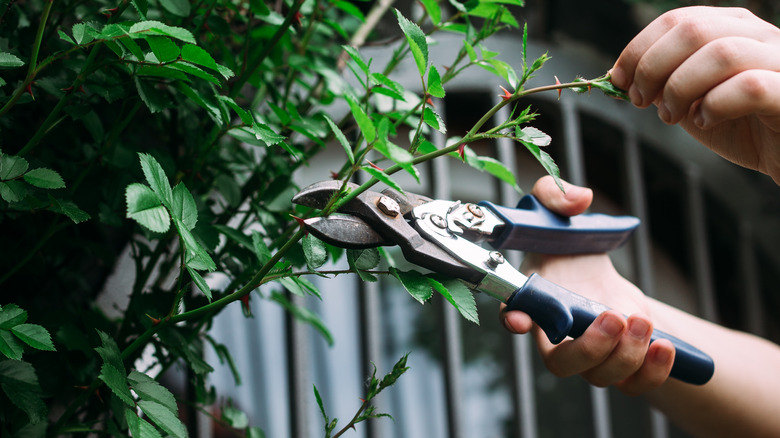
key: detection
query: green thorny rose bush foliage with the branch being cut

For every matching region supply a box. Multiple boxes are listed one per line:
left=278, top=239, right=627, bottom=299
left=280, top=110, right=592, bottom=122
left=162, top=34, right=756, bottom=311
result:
left=0, top=0, right=617, bottom=436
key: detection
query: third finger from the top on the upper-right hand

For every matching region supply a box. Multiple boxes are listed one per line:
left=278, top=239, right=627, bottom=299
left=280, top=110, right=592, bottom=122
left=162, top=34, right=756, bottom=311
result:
left=658, top=37, right=780, bottom=124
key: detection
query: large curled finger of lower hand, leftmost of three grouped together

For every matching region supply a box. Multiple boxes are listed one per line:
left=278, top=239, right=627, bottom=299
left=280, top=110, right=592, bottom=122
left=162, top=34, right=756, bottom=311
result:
left=534, top=310, right=626, bottom=377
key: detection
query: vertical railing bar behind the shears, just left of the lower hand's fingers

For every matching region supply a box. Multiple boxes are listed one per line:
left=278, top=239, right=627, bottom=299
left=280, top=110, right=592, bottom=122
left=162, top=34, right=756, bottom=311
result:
left=493, top=97, right=539, bottom=438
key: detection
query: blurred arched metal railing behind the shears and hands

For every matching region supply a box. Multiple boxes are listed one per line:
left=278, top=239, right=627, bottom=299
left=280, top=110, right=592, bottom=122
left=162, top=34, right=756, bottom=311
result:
left=204, top=35, right=780, bottom=438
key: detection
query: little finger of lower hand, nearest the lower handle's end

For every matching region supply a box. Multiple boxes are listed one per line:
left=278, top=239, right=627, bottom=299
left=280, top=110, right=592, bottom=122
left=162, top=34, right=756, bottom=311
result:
left=615, top=339, right=675, bottom=397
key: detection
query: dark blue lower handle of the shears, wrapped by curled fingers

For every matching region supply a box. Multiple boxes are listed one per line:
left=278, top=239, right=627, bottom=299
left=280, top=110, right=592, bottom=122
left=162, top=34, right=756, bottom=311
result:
left=507, top=274, right=715, bottom=385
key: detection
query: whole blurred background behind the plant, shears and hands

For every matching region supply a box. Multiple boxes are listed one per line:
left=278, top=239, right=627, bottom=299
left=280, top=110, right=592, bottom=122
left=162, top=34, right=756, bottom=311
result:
left=197, top=0, right=780, bottom=438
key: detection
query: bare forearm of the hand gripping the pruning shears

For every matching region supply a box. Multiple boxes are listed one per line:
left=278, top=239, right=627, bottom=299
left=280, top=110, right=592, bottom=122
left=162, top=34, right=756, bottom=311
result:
left=646, top=300, right=780, bottom=438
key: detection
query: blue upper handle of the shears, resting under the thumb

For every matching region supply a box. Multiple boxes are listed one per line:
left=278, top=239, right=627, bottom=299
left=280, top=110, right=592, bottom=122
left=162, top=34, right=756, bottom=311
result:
left=479, top=195, right=639, bottom=254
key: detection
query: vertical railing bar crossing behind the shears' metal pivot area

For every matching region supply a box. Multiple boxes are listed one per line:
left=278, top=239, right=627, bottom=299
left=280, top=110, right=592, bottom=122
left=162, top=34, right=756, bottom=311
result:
left=431, top=102, right=465, bottom=438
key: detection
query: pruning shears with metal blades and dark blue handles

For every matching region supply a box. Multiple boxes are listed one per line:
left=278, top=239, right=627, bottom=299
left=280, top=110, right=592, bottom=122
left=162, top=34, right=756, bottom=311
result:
left=293, top=181, right=715, bottom=385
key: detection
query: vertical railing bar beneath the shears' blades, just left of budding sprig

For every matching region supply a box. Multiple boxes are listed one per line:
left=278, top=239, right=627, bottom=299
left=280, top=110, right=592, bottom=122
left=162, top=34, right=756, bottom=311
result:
left=285, top=292, right=311, bottom=438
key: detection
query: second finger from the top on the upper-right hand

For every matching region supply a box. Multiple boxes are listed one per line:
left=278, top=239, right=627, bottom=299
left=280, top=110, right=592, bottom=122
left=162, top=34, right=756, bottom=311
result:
left=629, top=12, right=765, bottom=107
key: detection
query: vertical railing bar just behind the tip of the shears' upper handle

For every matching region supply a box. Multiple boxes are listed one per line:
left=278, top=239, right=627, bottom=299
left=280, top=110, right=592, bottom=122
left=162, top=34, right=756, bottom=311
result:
left=623, top=129, right=669, bottom=438
